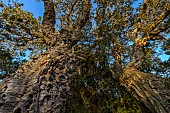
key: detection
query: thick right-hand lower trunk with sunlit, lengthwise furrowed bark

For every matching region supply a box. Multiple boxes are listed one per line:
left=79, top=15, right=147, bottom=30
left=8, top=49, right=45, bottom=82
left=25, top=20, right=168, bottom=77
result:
left=120, top=66, right=170, bottom=113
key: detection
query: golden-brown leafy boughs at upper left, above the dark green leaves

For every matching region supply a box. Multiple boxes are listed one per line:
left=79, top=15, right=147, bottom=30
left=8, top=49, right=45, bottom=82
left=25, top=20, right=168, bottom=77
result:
left=0, top=2, right=46, bottom=56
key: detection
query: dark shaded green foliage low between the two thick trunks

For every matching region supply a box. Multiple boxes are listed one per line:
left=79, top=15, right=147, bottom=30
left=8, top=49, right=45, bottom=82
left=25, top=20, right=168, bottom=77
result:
left=66, top=56, right=149, bottom=113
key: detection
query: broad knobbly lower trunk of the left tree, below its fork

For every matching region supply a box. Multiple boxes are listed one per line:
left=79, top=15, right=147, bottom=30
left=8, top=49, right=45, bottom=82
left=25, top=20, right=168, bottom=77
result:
left=0, top=35, right=79, bottom=113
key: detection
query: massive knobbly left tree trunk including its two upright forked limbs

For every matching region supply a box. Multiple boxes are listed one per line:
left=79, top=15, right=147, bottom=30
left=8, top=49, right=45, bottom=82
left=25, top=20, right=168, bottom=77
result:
left=0, top=0, right=91, bottom=113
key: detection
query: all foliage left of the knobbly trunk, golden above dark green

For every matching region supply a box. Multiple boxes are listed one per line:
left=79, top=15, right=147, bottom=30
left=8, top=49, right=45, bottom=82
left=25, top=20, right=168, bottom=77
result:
left=0, top=1, right=43, bottom=79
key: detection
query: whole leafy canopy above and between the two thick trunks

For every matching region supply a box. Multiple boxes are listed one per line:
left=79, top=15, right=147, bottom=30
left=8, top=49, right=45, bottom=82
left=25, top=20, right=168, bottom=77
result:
left=0, top=0, right=170, bottom=113
